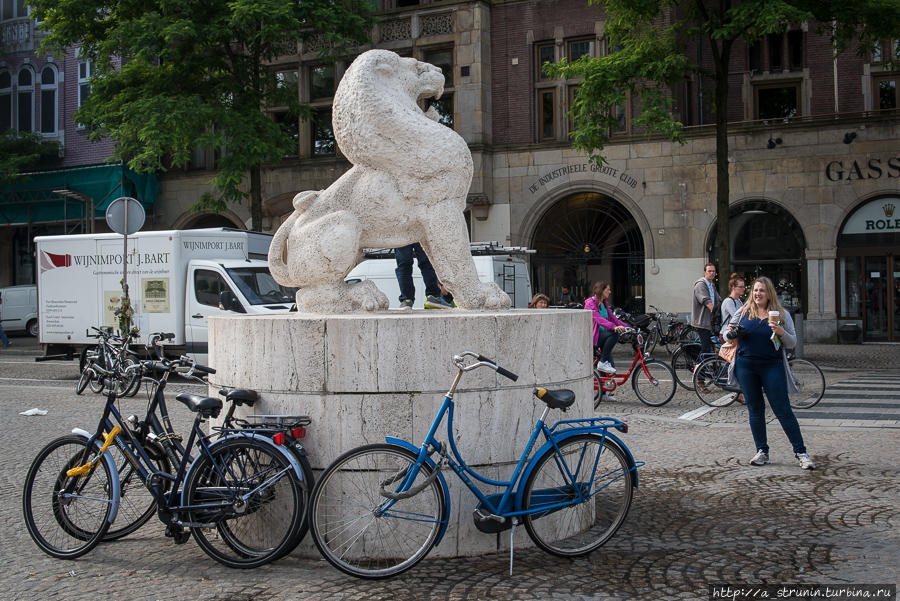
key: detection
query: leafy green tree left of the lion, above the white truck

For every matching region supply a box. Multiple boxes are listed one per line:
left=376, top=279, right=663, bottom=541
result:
left=29, top=0, right=372, bottom=230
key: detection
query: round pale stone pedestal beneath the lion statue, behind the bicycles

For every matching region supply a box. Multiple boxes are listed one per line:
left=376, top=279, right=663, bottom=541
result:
left=209, top=309, right=593, bottom=557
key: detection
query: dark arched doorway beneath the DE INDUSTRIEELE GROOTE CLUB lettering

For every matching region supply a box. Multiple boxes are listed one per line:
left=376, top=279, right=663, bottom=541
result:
left=531, top=192, right=644, bottom=312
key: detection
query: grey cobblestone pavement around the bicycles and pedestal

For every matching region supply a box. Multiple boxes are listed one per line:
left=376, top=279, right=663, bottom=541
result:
left=0, top=336, right=900, bottom=601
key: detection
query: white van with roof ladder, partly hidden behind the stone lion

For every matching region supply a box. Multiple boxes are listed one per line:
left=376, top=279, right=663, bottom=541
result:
left=345, top=242, right=534, bottom=309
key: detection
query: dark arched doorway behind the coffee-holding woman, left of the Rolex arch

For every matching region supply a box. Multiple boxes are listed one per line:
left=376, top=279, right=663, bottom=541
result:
left=706, top=200, right=807, bottom=313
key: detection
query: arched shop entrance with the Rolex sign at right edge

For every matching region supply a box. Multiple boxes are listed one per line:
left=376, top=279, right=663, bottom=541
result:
left=837, top=194, right=900, bottom=342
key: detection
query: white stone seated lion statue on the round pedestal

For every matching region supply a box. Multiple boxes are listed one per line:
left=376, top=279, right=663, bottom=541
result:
left=269, top=50, right=510, bottom=313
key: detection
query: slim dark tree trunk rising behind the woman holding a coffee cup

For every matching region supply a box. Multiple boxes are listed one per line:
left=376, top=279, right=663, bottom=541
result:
left=716, top=49, right=731, bottom=298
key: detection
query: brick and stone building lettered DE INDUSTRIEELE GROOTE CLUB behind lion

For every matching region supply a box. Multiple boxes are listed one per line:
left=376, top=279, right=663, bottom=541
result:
left=0, top=0, right=900, bottom=341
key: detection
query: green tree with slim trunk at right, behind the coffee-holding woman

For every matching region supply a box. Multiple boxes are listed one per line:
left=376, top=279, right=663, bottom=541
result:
left=545, top=0, right=900, bottom=295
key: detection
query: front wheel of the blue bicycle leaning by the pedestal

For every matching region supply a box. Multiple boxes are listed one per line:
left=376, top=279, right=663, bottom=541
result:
left=309, top=443, right=447, bottom=579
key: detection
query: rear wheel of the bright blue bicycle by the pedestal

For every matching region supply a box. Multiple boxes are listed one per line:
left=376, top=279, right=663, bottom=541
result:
left=522, top=434, right=634, bottom=557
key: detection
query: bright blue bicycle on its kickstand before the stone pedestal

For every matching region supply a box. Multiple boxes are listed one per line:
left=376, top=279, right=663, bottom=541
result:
left=310, top=351, right=643, bottom=578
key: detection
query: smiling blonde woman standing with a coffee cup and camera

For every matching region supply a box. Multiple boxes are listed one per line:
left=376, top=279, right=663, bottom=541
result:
left=725, top=277, right=815, bottom=470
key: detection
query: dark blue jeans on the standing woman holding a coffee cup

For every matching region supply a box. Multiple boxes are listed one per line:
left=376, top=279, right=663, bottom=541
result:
left=734, top=355, right=806, bottom=453
